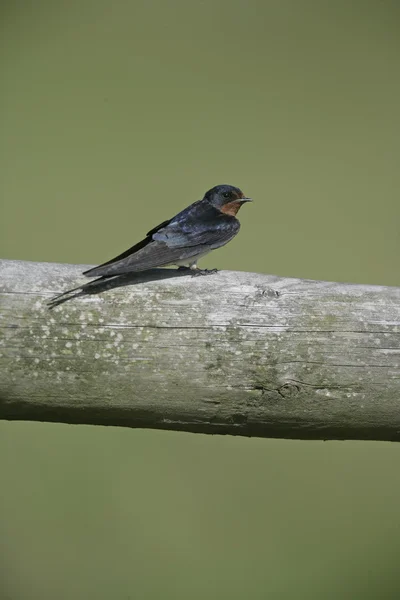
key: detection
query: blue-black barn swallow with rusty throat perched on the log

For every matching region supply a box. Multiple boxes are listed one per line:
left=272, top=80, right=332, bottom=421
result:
left=48, top=185, right=251, bottom=302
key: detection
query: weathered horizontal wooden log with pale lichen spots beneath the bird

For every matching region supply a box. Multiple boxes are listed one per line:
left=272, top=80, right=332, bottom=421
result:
left=0, top=260, right=400, bottom=441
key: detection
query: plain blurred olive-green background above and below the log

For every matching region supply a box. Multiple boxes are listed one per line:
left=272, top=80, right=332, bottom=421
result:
left=0, top=0, right=400, bottom=600
